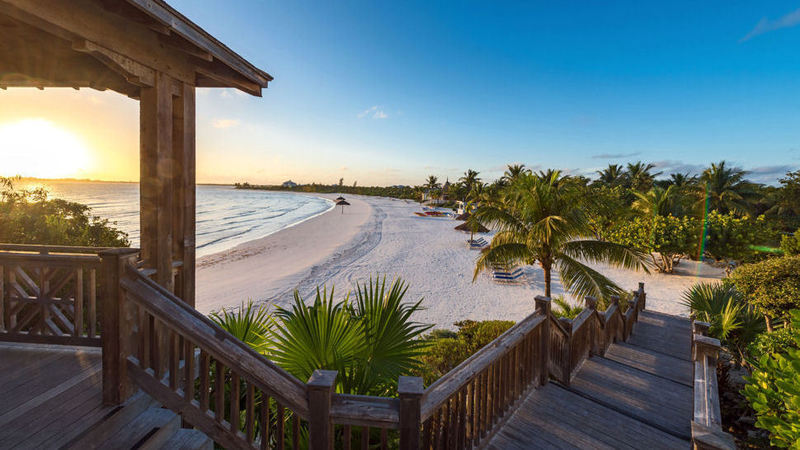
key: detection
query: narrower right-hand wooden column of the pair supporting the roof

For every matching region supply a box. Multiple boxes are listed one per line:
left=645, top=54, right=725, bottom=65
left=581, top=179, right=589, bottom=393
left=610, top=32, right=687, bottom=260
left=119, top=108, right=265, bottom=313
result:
left=172, top=83, right=196, bottom=306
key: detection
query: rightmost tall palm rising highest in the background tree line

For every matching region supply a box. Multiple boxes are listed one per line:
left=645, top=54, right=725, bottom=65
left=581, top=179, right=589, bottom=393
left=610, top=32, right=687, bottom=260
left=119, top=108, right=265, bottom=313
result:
left=698, top=161, right=753, bottom=214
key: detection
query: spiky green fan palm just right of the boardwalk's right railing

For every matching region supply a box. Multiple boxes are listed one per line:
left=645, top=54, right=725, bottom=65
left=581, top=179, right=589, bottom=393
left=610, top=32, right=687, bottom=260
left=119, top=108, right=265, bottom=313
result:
left=681, top=282, right=765, bottom=362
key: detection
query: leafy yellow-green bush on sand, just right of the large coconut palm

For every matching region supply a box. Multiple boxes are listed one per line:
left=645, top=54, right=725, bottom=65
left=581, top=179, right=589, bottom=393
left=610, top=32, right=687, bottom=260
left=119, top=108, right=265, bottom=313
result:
left=608, top=215, right=700, bottom=273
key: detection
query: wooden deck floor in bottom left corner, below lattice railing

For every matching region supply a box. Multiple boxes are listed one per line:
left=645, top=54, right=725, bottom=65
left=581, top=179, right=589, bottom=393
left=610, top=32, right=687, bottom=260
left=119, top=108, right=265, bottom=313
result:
left=0, top=343, right=114, bottom=449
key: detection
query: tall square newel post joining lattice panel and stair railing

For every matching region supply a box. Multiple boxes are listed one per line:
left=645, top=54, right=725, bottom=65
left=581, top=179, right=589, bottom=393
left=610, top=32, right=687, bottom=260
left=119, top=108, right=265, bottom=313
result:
left=98, top=248, right=138, bottom=405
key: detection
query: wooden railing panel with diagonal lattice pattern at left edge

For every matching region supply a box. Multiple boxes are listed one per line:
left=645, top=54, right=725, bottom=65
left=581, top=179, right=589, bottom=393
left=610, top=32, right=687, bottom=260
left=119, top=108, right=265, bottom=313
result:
left=0, top=244, right=117, bottom=346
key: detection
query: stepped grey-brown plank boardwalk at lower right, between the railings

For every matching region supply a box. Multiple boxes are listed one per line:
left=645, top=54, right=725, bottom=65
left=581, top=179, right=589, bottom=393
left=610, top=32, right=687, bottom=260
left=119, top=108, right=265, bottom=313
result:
left=488, top=311, right=693, bottom=450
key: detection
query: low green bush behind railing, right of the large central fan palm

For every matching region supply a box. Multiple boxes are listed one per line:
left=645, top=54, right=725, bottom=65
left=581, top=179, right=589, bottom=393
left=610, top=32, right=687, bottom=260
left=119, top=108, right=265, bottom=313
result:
left=415, top=320, right=514, bottom=386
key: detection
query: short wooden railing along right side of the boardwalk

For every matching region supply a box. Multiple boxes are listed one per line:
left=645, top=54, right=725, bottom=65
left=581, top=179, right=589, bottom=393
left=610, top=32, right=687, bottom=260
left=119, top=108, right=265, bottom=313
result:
left=692, top=321, right=736, bottom=449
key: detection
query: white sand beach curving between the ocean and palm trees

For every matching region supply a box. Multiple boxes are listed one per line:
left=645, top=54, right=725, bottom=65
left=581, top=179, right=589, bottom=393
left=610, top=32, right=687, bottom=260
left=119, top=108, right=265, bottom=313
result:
left=197, top=195, right=723, bottom=328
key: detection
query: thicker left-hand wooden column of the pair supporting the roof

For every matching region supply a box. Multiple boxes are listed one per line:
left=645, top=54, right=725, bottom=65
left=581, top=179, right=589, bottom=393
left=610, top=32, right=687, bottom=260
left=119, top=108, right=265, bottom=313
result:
left=139, top=72, right=174, bottom=291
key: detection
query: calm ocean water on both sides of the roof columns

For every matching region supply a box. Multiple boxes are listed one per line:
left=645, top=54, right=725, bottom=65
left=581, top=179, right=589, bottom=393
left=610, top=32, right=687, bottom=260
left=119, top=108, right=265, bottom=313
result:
left=18, top=181, right=334, bottom=257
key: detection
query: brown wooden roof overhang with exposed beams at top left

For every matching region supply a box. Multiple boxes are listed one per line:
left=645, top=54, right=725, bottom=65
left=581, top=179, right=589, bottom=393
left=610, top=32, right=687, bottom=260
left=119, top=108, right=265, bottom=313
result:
left=0, top=0, right=272, bottom=99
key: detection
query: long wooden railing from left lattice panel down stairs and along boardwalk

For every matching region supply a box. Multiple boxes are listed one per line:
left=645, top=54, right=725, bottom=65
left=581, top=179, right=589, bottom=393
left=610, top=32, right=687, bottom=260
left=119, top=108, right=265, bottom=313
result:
left=0, top=246, right=645, bottom=449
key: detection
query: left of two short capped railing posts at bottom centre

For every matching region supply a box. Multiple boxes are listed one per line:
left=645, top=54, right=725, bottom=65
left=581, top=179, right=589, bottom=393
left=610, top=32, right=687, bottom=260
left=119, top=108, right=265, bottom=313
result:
left=307, top=370, right=337, bottom=450
